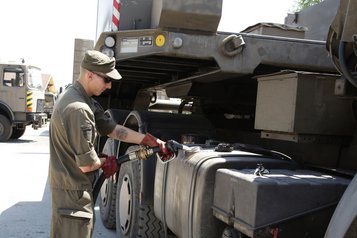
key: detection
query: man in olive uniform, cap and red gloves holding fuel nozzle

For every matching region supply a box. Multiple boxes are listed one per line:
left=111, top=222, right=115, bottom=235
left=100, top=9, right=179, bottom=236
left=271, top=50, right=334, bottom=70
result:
left=49, top=50, right=170, bottom=238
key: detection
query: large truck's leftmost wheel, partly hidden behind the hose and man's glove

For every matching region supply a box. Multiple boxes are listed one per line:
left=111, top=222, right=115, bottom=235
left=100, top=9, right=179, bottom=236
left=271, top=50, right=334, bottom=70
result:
left=98, top=138, right=117, bottom=230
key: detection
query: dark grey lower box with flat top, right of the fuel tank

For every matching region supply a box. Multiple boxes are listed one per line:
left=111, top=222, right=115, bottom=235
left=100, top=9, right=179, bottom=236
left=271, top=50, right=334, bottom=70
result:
left=213, top=169, right=350, bottom=237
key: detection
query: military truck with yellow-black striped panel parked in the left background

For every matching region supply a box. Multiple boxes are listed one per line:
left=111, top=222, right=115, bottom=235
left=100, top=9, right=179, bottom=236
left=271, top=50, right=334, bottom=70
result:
left=0, top=62, right=47, bottom=141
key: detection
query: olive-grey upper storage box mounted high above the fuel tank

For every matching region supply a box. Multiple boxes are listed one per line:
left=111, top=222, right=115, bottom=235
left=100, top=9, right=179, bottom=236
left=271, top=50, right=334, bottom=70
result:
left=255, top=71, right=354, bottom=136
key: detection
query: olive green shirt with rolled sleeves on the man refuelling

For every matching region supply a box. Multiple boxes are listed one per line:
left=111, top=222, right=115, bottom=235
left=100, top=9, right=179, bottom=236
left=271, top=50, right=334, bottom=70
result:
left=49, top=82, right=116, bottom=190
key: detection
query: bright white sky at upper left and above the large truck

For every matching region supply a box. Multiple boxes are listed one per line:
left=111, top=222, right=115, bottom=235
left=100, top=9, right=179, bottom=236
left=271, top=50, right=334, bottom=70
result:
left=0, top=0, right=296, bottom=88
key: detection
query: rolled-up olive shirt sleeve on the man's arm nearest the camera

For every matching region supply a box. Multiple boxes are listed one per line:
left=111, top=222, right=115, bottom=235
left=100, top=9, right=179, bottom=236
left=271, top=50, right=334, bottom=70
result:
left=64, top=108, right=98, bottom=167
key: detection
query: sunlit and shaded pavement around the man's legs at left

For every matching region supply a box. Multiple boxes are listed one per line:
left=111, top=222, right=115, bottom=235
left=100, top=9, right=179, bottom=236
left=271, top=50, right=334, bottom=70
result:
left=0, top=126, right=116, bottom=238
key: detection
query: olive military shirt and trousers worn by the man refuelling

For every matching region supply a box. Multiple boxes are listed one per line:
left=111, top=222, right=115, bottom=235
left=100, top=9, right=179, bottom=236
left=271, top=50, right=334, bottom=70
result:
left=49, top=82, right=116, bottom=238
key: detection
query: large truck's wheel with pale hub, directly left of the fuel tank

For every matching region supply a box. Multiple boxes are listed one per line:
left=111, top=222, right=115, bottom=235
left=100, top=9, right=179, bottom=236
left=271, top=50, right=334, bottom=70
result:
left=116, top=146, right=165, bottom=238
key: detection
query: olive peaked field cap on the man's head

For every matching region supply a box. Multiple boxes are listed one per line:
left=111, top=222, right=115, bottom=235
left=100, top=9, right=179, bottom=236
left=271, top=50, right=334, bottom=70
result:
left=81, top=50, right=121, bottom=80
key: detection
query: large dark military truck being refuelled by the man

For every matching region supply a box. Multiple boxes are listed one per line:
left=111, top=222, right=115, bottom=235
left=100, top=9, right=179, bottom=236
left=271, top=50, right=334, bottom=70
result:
left=89, top=0, right=357, bottom=238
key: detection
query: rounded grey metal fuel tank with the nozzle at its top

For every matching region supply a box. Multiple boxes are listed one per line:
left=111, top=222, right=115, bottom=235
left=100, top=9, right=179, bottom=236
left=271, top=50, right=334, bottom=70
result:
left=154, top=147, right=296, bottom=238
